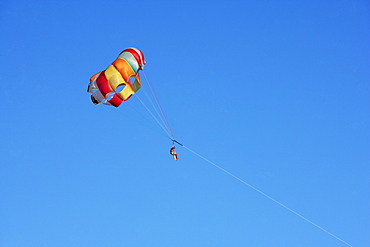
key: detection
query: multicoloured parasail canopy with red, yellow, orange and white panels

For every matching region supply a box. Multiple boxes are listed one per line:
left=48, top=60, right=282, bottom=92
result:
left=87, top=48, right=146, bottom=107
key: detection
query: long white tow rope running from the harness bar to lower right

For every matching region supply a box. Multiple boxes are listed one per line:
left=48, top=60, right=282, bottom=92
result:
left=181, top=145, right=352, bottom=247
